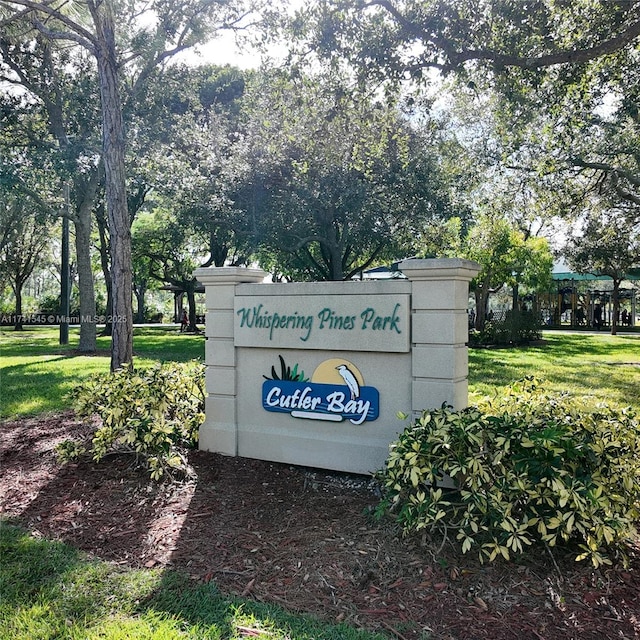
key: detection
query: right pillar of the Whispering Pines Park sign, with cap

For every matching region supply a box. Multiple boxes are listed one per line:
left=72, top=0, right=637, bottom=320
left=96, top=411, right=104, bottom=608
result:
left=399, top=258, right=480, bottom=414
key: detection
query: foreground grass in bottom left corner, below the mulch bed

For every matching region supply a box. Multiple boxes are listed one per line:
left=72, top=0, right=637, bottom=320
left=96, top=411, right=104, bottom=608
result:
left=0, top=522, right=382, bottom=640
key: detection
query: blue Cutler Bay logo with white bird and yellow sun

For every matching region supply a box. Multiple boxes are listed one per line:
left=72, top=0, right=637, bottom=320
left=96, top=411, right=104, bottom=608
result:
left=262, top=356, right=380, bottom=424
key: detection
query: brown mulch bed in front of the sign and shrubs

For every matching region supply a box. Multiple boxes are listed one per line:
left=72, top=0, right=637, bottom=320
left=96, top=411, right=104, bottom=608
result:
left=0, top=413, right=640, bottom=640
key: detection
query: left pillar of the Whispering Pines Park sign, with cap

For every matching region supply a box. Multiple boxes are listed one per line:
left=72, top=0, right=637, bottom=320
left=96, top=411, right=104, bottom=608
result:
left=195, top=267, right=267, bottom=456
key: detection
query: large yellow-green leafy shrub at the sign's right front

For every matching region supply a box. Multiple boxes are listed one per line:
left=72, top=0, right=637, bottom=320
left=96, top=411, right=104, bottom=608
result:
left=378, top=379, right=640, bottom=566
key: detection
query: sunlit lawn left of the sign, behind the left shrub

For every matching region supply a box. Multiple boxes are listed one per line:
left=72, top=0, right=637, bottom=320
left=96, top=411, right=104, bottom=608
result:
left=0, top=326, right=204, bottom=418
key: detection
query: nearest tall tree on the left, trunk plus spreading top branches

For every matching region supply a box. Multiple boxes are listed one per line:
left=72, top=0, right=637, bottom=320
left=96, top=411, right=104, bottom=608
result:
left=0, top=0, right=260, bottom=369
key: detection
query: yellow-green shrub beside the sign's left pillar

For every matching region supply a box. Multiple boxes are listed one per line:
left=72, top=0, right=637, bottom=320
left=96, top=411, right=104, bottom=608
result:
left=57, top=362, right=205, bottom=479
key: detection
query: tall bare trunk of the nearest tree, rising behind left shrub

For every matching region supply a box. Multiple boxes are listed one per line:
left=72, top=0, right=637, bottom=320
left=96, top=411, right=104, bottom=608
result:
left=90, top=2, right=133, bottom=371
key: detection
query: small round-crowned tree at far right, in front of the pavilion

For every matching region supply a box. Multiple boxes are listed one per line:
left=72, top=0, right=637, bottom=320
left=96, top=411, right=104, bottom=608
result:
left=566, top=208, right=640, bottom=335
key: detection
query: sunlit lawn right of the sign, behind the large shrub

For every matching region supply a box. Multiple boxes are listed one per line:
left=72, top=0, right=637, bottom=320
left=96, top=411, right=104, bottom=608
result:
left=469, top=332, right=640, bottom=409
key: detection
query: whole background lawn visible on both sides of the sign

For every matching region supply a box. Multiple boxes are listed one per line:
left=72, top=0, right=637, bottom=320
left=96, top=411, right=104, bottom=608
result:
left=0, top=326, right=640, bottom=418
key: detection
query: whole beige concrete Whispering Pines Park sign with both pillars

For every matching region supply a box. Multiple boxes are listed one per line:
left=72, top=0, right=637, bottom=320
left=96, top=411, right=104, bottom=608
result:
left=195, top=258, right=479, bottom=473
